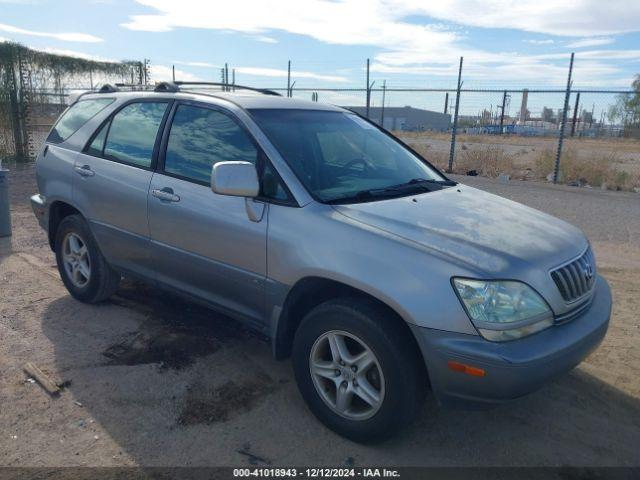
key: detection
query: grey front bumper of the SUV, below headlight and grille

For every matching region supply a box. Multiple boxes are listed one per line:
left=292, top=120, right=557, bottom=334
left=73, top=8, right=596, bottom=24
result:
left=411, top=276, right=611, bottom=408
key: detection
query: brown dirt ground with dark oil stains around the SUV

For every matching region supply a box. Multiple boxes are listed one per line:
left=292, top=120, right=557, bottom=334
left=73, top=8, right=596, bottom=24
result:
left=0, top=166, right=640, bottom=466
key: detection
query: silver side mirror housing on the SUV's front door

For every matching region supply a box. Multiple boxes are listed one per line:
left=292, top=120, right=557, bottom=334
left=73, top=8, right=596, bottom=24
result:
left=211, top=162, right=260, bottom=197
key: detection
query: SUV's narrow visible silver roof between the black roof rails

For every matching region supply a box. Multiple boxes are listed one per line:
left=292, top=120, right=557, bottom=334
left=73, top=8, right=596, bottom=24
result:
left=82, top=88, right=345, bottom=112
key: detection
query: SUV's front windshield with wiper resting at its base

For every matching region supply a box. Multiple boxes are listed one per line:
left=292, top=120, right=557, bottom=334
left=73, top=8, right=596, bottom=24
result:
left=251, top=109, right=452, bottom=203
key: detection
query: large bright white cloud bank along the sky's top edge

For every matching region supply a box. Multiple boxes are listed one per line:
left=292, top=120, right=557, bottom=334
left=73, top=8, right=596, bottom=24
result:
left=125, top=0, right=640, bottom=39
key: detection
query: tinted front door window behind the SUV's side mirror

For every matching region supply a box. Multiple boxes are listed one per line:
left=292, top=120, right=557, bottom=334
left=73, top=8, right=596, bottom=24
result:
left=164, top=105, right=258, bottom=183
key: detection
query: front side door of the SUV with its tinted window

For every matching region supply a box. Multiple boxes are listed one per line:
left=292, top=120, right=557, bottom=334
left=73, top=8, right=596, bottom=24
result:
left=148, top=102, right=267, bottom=324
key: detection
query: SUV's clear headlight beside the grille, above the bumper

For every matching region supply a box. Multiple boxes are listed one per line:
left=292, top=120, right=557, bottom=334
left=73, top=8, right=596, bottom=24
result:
left=453, top=278, right=553, bottom=342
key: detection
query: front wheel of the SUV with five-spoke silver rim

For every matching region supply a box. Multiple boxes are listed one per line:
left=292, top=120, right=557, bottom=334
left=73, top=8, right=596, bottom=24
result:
left=293, top=298, right=428, bottom=443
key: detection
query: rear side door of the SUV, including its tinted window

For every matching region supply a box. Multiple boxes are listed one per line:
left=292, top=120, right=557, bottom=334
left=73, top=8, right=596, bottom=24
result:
left=73, top=100, right=169, bottom=278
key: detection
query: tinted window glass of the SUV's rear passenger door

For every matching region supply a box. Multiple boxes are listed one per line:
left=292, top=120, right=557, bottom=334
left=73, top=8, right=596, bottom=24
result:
left=104, top=102, right=167, bottom=167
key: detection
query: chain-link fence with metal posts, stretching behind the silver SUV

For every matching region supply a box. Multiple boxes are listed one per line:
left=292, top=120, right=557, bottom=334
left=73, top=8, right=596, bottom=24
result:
left=0, top=47, right=640, bottom=190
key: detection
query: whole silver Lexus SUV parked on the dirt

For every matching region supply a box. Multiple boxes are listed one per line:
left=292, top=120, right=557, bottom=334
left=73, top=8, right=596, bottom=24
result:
left=31, top=84, right=611, bottom=442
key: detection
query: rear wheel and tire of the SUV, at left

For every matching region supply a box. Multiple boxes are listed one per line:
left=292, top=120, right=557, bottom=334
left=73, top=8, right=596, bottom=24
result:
left=55, top=215, right=120, bottom=303
